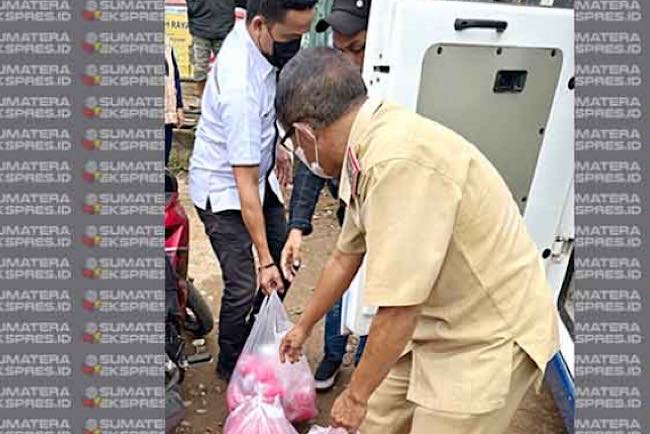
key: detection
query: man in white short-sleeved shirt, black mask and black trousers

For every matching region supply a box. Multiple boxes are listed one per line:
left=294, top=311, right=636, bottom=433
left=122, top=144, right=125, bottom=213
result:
left=189, top=0, right=316, bottom=379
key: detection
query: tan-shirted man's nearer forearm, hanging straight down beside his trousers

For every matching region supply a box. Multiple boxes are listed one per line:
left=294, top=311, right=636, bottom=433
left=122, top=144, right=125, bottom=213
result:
left=348, top=306, right=420, bottom=402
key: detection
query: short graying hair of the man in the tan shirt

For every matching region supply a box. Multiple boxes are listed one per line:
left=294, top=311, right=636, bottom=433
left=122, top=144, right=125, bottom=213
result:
left=275, top=47, right=368, bottom=129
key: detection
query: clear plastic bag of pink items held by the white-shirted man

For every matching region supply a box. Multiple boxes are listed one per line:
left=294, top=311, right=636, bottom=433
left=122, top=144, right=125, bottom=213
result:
left=226, top=292, right=318, bottom=422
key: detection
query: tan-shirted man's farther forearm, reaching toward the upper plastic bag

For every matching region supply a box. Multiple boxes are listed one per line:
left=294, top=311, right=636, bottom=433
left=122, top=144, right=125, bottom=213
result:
left=298, top=249, right=363, bottom=330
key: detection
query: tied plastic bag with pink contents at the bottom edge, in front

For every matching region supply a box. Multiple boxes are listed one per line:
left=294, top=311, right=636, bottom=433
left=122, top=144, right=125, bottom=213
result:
left=223, top=396, right=298, bottom=434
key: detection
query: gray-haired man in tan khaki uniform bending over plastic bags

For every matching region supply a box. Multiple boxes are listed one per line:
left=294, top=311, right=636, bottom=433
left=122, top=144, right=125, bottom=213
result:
left=276, top=48, right=559, bottom=434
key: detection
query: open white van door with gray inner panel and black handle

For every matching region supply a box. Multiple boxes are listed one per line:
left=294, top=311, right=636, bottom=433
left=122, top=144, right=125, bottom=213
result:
left=363, top=0, right=574, bottom=432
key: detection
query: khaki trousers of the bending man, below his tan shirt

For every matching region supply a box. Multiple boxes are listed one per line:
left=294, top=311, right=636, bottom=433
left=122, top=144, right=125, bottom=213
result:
left=359, top=345, right=542, bottom=434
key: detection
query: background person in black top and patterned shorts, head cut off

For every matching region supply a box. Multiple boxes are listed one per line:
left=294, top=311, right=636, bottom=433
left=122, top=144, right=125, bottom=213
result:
left=187, top=0, right=235, bottom=101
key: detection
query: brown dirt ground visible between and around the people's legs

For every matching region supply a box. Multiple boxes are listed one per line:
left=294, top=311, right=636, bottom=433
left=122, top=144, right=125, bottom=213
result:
left=170, top=83, right=566, bottom=434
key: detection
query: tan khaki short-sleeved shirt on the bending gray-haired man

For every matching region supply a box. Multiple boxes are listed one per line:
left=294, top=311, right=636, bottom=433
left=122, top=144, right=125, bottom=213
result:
left=338, top=100, right=559, bottom=413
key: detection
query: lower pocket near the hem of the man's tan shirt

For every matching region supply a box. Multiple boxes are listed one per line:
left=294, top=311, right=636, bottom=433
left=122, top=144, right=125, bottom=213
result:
left=407, top=341, right=514, bottom=414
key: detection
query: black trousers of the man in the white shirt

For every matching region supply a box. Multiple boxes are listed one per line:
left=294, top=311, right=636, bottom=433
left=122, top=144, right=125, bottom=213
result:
left=196, top=184, right=289, bottom=378
